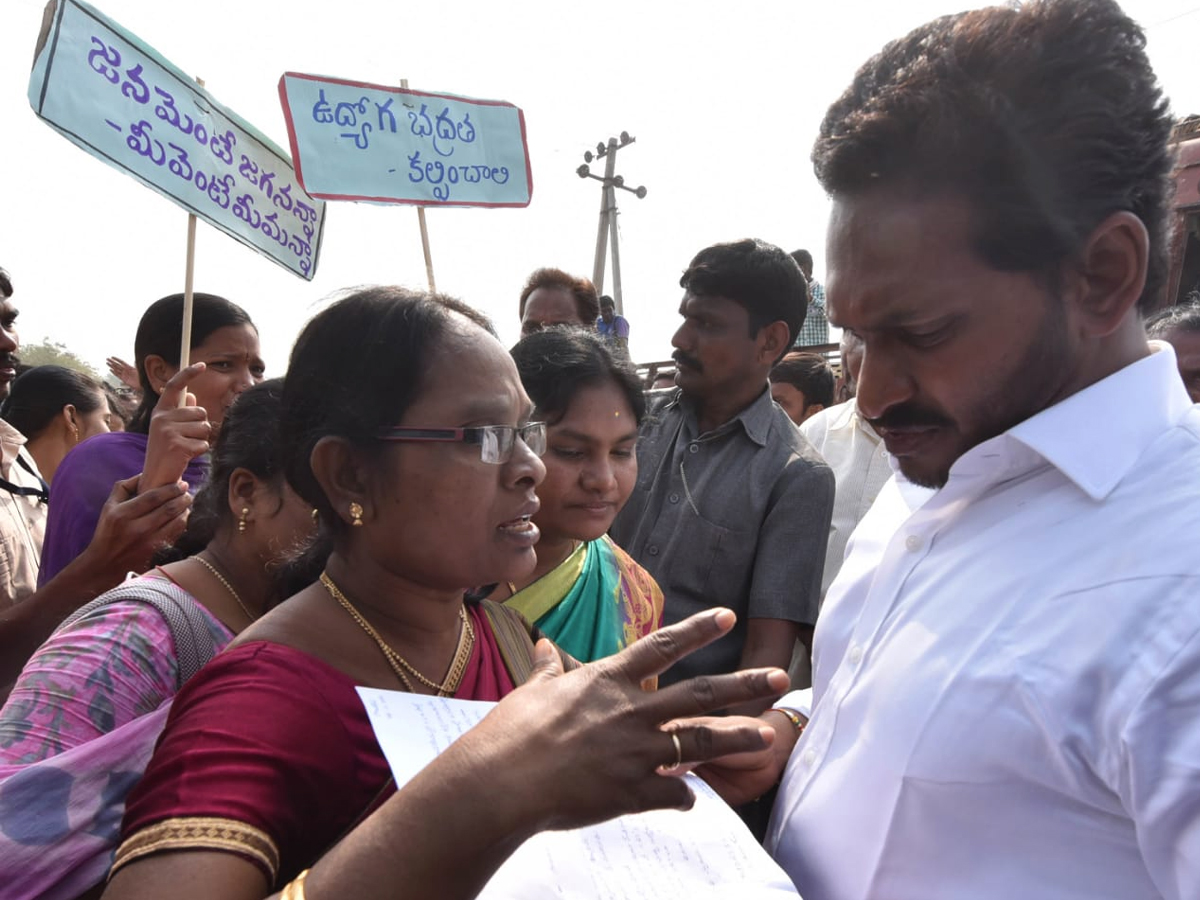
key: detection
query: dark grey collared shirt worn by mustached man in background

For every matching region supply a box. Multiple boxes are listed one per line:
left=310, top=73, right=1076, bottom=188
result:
left=610, top=389, right=834, bottom=684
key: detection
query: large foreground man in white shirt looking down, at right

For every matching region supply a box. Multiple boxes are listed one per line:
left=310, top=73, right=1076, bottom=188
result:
left=700, top=0, right=1200, bottom=900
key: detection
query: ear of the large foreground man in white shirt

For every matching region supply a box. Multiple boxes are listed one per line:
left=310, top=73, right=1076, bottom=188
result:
left=1063, top=211, right=1150, bottom=337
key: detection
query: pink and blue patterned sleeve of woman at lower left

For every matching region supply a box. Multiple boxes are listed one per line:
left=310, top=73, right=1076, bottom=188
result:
left=0, top=601, right=178, bottom=764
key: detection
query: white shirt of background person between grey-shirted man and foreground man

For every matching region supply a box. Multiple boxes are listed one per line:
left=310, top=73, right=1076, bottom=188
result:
left=800, top=400, right=892, bottom=600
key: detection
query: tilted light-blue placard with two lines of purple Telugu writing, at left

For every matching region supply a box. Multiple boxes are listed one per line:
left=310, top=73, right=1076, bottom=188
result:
left=29, top=0, right=325, bottom=281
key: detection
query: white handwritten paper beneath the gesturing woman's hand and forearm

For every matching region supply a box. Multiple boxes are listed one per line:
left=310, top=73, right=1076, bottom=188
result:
left=358, top=688, right=797, bottom=900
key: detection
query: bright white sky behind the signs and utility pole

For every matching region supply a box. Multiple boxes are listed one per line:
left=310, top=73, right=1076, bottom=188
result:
left=0, top=0, right=1200, bottom=374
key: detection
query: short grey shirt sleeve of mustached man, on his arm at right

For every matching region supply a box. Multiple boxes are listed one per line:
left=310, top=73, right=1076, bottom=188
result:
left=748, top=457, right=834, bottom=625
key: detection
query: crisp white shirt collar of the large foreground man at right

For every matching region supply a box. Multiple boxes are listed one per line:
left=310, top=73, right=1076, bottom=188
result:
left=952, top=341, right=1192, bottom=500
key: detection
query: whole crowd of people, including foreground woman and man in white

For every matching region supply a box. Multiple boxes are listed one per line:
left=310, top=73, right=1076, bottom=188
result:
left=0, top=0, right=1200, bottom=900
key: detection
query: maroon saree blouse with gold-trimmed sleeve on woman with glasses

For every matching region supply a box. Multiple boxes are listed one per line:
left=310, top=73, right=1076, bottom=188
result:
left=113, top=601, right=535, bottom=887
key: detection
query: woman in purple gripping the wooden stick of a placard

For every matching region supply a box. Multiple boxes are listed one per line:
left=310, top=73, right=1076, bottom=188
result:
left=38, top=294, right=264, bottom=584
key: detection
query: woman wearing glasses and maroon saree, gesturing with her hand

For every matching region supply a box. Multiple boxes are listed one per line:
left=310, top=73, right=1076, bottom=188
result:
left=106, top=288, right=786, bottom=900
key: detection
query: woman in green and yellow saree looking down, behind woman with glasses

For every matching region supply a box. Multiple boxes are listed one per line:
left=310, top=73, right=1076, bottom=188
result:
left=492, top=329, right=662, bottom=662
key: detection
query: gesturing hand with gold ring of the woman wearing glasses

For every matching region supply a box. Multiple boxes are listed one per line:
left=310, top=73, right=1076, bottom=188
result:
left=448, top=610, right=788, bottom=829
